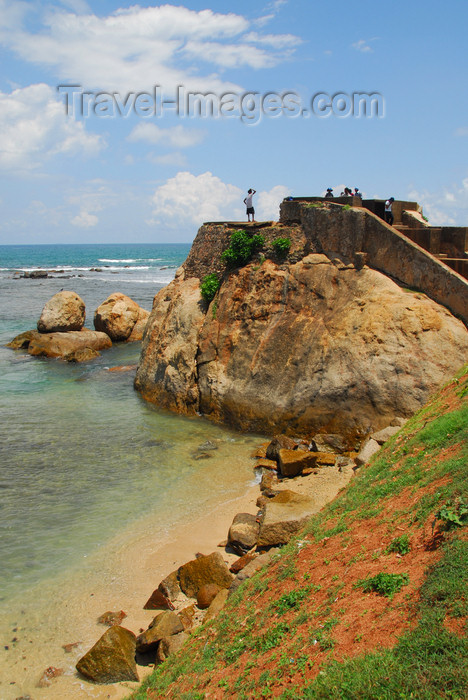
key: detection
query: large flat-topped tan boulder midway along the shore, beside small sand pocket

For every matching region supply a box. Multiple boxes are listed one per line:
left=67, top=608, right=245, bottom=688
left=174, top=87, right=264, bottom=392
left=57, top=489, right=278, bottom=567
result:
left=256, top=492, right=317, bottom=548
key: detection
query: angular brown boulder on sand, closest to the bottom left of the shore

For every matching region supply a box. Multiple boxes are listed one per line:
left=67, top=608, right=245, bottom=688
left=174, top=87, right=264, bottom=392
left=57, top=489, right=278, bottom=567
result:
left=76, top=625, right=138, bottom=683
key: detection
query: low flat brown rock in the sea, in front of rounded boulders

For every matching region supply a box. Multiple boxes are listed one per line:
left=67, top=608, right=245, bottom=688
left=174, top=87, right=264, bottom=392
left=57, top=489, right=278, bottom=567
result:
left=28, top=328, right=112, bottom=358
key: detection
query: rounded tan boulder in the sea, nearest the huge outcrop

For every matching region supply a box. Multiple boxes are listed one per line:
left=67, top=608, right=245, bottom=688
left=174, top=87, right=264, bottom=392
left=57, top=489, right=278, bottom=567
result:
left=94, top=292, right=149, bottom=341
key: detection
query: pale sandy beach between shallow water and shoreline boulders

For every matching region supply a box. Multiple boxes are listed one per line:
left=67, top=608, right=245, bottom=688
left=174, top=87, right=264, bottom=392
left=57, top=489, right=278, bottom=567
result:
left=0, top=460, right=353, bottom=700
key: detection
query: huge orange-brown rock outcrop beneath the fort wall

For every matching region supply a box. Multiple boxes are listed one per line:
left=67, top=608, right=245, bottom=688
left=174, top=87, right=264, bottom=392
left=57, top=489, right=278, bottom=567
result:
left=135, top=221, right=468, bottom=437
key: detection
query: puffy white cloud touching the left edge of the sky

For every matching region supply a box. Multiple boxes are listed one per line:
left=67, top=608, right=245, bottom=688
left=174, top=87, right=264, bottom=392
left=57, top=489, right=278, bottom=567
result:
left=0, top=84, right=104, bottom=172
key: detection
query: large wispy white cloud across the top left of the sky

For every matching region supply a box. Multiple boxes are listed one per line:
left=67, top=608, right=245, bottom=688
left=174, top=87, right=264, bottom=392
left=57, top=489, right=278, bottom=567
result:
left=0, top=0, right=300, bottom=91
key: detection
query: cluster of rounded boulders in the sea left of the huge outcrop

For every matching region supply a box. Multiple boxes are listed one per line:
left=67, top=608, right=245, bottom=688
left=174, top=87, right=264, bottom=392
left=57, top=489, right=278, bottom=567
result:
left=8, top=291, right=149, bottom=362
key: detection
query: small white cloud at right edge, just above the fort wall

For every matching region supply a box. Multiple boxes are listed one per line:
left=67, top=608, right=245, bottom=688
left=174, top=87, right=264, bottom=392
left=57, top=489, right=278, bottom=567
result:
left=408, top=177, right=468, bottom=226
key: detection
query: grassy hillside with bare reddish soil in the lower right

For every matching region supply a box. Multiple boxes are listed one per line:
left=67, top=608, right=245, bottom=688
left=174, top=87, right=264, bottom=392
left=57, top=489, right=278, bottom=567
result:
left=132, top=366, right=468, bottom=700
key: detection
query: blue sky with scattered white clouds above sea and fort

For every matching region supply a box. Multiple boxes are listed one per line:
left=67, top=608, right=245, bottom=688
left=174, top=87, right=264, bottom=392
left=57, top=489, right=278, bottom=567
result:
left=0, top=0, right=468, bottom=244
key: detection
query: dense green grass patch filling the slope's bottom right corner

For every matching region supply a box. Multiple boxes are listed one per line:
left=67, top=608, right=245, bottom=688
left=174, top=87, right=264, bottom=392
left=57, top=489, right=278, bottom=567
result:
left=296, top=538, right=468, bottom=700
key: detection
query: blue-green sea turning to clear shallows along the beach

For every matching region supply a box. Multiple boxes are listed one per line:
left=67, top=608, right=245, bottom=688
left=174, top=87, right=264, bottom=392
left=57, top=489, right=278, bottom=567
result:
left=0, top=244, right=258, bottom=600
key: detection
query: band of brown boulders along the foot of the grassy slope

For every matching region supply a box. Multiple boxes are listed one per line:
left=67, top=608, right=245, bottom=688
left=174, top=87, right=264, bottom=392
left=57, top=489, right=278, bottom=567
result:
left=62, top=418, right=405, bottom=685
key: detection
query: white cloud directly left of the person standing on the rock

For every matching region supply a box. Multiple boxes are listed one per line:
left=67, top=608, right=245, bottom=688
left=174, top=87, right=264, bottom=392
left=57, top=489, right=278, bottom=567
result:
left=152, top=172, right=242, bottom=225
